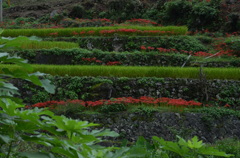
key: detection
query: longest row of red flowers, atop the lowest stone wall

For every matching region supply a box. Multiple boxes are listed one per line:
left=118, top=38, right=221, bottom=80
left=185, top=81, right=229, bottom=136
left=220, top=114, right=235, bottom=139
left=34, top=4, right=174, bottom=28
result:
left=28, top=96, right=202, bottom=108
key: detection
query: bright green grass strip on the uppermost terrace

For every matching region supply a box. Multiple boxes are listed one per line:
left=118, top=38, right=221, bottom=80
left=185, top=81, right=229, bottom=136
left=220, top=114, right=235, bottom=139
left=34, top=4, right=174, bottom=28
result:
left=2, top=26, right=188, bottom=37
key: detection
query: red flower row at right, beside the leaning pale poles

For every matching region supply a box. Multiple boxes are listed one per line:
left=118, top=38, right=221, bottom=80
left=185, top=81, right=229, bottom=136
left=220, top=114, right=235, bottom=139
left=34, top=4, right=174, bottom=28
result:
left=140, top=46, right=232, bottom=57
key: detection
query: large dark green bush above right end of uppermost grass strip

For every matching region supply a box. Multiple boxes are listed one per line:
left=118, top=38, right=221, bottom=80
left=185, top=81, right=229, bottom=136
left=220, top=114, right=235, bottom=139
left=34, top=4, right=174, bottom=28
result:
left=160, top=0, right=222, bottom=31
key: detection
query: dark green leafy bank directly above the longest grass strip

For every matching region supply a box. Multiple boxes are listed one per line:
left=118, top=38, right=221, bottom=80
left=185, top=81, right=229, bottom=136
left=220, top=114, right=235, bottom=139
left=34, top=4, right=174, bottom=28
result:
left=10, top=49, right=240, bottom=67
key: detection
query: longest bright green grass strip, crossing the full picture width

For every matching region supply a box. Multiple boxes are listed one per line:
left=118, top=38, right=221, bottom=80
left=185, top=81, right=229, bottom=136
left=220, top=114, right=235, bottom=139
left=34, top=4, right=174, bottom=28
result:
left=0, top=64, right=240, bottom=80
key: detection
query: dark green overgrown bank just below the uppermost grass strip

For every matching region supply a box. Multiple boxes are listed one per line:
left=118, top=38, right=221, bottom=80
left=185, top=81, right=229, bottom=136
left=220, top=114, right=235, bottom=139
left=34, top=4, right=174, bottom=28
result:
left=45, top=35, right=207, bottom=52
